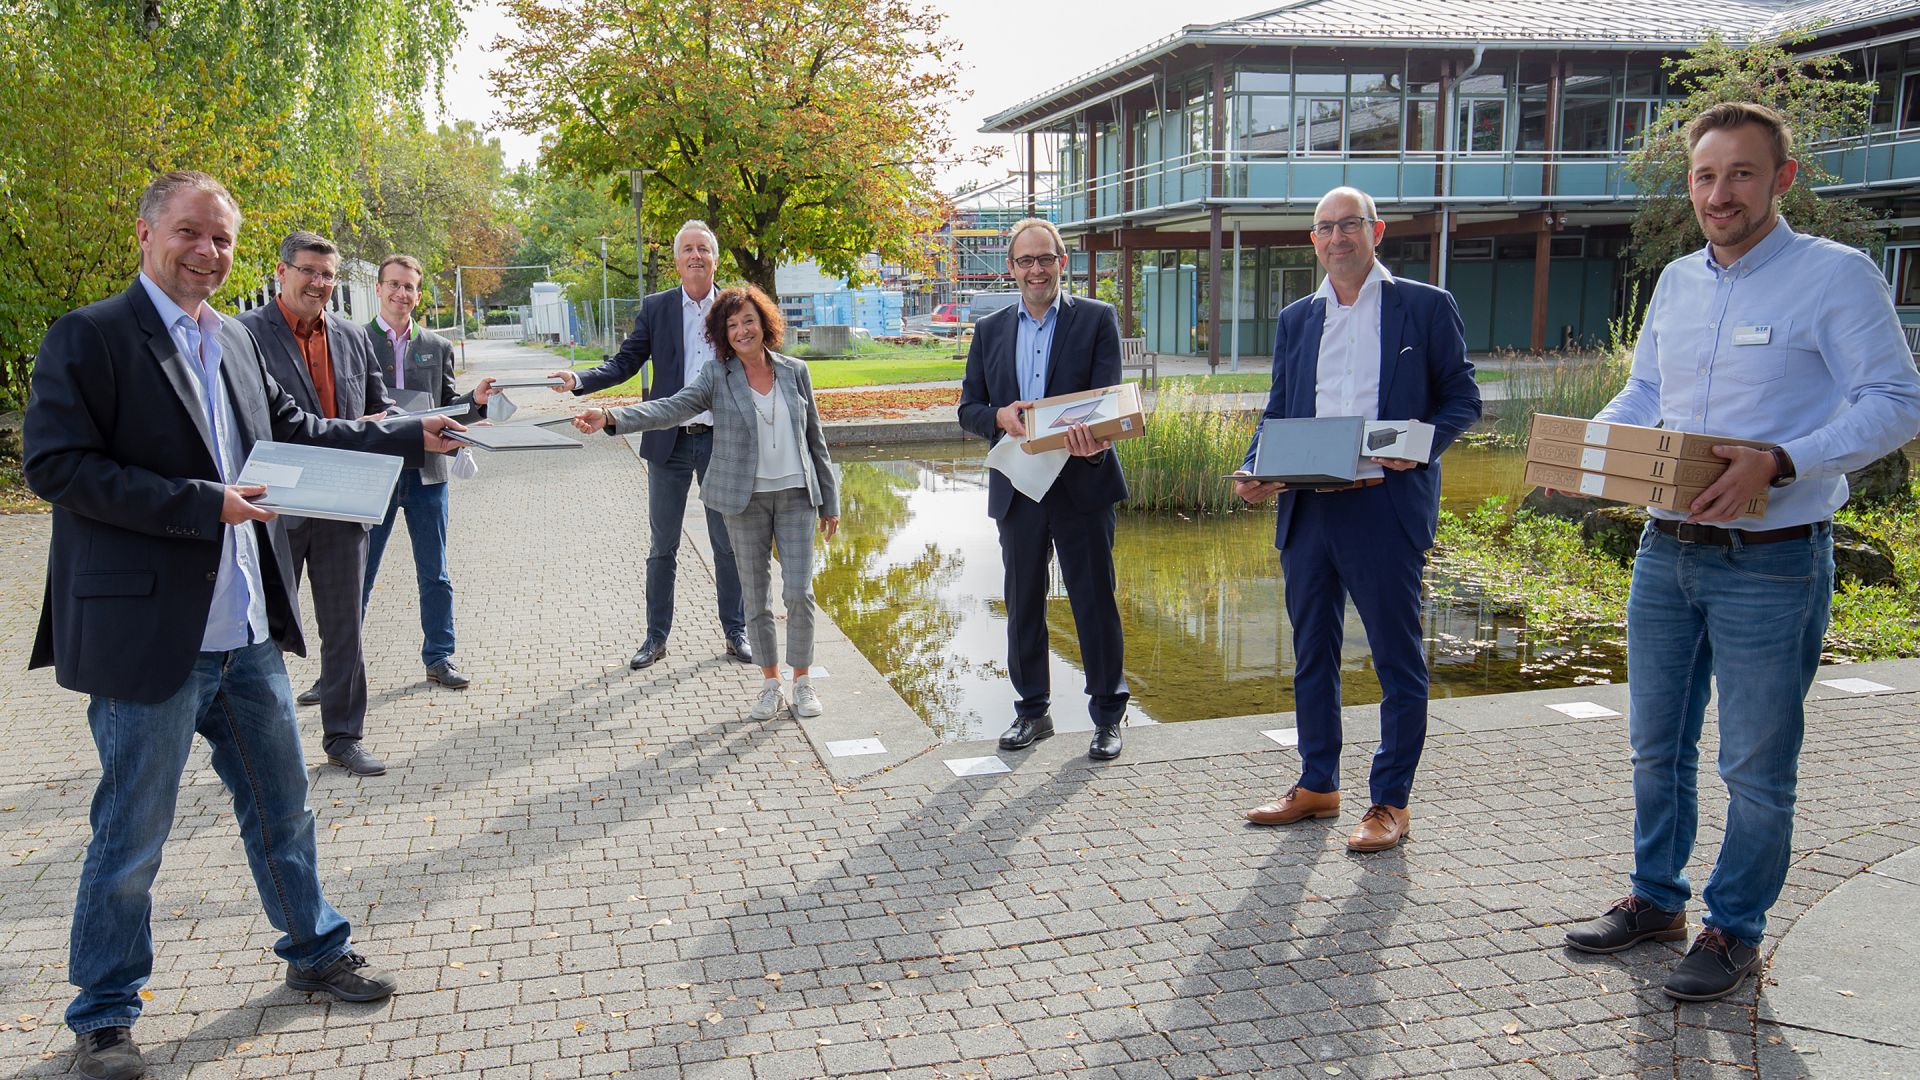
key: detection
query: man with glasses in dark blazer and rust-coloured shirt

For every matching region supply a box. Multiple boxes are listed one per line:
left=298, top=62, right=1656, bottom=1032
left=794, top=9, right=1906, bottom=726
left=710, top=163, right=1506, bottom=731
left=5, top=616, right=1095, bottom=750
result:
left=238, top=233, right=388, bottom=776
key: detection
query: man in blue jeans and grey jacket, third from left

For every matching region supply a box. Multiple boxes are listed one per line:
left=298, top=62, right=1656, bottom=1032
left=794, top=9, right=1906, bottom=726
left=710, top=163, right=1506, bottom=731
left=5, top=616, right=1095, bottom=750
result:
left=361, top=256, right=493, bottom=690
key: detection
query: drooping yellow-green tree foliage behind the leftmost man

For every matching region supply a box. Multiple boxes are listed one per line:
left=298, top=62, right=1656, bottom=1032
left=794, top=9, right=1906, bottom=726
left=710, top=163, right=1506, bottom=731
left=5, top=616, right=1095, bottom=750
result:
left=0, top=0, right=461, bottom=407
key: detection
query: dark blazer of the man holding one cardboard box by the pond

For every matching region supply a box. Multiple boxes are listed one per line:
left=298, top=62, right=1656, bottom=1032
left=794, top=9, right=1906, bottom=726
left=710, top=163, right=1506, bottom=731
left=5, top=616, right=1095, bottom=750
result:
left=960, top=294, right=1127, bottom=519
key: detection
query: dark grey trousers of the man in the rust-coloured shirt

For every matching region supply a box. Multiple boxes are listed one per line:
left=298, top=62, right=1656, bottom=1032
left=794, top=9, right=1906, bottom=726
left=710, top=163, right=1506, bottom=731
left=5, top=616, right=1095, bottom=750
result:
left=286, top=519, right=367, bottom=753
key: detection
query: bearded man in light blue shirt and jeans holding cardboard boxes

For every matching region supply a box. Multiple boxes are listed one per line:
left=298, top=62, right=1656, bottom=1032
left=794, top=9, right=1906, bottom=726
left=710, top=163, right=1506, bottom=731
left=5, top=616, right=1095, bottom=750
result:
left=1567, top=104, right=1920, bottom=1001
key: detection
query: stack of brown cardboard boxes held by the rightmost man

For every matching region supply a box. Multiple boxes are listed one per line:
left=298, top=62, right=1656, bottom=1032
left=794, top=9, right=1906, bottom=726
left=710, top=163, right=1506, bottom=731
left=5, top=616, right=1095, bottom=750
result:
left=1526, top=413, right=1768, bottom=517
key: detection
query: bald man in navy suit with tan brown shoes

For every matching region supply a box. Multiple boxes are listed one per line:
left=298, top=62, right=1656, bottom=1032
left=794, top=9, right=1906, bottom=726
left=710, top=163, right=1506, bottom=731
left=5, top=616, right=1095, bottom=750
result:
left=1236, top=188, right=1480, bottom=851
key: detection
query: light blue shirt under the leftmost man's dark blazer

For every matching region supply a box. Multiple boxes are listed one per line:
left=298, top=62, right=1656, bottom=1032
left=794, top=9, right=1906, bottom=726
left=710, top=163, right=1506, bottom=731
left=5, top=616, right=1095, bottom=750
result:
left=140, top=273, right=267, bottom=653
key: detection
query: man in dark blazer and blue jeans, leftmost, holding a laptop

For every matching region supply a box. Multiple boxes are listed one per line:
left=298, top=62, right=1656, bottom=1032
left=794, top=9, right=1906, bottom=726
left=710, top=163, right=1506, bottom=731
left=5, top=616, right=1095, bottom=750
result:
left=23, top=173, right=468, bottom=1080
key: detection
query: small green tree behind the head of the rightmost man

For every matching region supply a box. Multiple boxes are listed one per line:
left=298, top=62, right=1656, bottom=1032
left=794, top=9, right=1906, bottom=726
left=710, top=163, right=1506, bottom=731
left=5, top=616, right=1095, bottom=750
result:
left=1624, top=33, right=1882, bottom=279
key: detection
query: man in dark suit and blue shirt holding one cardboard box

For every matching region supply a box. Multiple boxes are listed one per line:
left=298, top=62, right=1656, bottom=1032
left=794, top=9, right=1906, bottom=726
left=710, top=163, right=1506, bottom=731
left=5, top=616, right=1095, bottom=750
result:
left=960, top=217, right=1129, bottom=761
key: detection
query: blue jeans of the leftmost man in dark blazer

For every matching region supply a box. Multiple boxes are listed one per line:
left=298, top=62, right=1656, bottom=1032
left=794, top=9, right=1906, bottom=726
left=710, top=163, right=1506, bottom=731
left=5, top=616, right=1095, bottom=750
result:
left=67, top=642, right=351, bottom=1034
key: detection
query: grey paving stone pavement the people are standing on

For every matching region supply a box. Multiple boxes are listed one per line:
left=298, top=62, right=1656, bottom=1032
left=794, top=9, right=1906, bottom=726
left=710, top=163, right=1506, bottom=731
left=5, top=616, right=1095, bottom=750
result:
left=0, top=346, right=1920, bottom=1080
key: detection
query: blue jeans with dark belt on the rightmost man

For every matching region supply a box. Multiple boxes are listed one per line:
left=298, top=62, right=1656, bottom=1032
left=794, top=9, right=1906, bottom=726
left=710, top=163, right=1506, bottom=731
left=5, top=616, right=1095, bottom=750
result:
left=1626, top=525, right=1834, bottom=945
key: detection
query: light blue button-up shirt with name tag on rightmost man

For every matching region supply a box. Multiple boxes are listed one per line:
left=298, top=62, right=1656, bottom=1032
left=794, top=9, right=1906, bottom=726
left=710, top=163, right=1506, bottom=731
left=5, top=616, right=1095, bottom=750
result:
left=1594, top=217, right=1920, bottom=530
